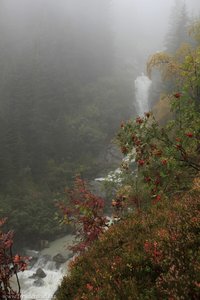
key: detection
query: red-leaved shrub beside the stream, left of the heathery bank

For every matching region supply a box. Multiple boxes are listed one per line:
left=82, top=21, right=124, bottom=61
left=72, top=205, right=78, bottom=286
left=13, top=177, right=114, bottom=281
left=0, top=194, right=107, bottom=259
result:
left=57, top=177, right=107, bottom=252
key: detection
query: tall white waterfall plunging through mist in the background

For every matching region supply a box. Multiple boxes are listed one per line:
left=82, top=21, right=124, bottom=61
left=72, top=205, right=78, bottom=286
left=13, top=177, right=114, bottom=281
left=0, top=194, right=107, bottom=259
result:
left=135, top=74, right=152, bottom=116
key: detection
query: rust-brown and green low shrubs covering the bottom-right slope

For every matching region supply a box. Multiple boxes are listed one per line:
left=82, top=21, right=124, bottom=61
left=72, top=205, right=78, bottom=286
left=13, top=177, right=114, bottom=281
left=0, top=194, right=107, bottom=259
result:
left=57, top=193, right=200, bottom=300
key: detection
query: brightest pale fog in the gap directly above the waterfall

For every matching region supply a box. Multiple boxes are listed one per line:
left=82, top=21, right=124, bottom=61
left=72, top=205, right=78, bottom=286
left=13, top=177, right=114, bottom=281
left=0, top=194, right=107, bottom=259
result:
left=113, top=0, right=200, bottom=69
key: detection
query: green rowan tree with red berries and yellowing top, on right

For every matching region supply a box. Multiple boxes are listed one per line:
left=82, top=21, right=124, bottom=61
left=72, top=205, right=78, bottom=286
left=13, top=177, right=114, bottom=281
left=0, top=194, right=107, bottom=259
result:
left=117, top=27, right=200, bottom=211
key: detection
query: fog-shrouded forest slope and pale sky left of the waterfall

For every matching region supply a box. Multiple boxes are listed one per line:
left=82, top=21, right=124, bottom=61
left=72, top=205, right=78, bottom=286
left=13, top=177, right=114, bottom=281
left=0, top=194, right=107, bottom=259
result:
left=0, top=0, right=200, bottom=248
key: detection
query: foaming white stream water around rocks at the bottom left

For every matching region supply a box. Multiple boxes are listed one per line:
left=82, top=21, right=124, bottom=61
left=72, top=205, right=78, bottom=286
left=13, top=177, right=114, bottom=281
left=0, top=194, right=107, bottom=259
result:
left=13, top=235, right=74, bottom=300
